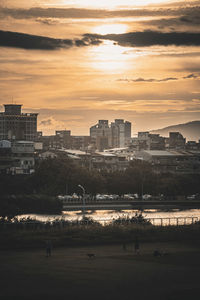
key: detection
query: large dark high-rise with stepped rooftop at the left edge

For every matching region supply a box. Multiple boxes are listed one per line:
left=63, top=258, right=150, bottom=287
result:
left=0, top=104, right=38, bottom=141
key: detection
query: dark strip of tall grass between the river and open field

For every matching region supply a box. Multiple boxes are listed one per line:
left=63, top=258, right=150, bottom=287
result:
left=0, top=224, right=200, bottom=250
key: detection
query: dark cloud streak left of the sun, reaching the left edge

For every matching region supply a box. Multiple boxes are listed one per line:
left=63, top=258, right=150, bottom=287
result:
left=0, top=30, right=101, bottom=50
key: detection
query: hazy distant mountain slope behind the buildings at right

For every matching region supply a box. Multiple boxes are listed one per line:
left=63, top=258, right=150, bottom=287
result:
left=150, top=121, right=200, bottom=141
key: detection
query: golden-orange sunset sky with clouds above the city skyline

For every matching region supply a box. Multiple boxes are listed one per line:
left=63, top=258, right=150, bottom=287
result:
left=0, top=0, right=200, bottom=135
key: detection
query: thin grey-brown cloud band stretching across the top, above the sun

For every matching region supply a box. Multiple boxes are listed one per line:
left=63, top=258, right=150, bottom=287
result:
left=0, top=5, right=200, bottom=19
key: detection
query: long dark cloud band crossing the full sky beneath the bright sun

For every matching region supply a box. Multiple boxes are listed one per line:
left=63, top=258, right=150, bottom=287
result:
left=0, top=30, right=200, bottom=50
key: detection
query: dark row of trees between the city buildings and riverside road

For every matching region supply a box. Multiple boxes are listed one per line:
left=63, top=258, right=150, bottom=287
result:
left=0, top=158, right=200, bottom=197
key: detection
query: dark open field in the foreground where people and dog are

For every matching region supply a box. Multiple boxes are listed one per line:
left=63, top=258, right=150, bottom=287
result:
left=0, top=243, right=200, bottom=300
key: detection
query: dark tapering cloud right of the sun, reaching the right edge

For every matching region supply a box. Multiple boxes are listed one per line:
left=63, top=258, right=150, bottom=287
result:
left=84, top=30, right=200, bottom=47
